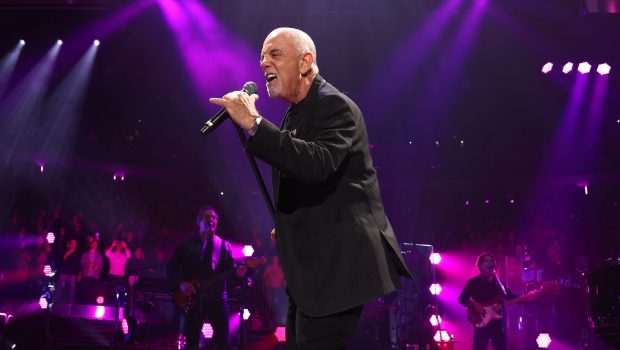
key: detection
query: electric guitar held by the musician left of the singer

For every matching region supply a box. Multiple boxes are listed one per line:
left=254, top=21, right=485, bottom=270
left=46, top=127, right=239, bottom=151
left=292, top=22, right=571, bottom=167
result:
left=172, top=258, right=267, bottom=314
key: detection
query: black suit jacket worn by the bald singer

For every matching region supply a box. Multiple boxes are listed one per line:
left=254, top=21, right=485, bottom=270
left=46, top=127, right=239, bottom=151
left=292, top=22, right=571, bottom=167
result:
left=246, top=76, right=411, bottom=316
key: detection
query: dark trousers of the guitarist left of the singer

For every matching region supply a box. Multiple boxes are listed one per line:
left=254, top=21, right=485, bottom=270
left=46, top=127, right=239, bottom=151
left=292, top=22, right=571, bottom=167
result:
left=182, top=300, right=230, bottom=350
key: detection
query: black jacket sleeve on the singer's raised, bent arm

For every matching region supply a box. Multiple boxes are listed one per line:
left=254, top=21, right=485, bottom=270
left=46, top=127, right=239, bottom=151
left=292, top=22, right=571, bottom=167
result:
left=246, top=95, right=356, bottom=183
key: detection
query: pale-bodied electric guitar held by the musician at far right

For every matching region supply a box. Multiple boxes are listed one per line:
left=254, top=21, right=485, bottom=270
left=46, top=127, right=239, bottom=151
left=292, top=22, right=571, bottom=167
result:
left=467, top=282, right=559, bottom=328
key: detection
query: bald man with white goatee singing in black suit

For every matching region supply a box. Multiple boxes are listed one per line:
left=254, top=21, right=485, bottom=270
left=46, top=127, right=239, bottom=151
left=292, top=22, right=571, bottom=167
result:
left=210, top=28, right=412, bottom=350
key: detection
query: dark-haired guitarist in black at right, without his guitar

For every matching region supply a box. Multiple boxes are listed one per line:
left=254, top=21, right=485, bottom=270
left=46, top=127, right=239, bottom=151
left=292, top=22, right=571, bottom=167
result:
left=459, top=253, right=529, bottom=350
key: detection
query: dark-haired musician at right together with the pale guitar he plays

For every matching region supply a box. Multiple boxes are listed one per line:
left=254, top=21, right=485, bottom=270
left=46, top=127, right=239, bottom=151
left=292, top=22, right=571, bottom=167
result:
left=459, top=253, right=537, bottom=350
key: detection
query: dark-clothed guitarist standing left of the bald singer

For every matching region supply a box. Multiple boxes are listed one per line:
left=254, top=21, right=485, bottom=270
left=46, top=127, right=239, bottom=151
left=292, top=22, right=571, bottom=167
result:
left=167, top=206, right=245, bottom=350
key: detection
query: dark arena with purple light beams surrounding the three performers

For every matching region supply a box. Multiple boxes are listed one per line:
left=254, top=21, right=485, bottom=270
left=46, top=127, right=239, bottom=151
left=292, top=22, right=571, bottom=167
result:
left=0, top=0, right=620, bottom=350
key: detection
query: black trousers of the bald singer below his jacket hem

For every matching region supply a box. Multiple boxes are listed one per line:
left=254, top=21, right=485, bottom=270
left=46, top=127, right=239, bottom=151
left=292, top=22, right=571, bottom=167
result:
left=286, top=298, right=364, bottom=350
